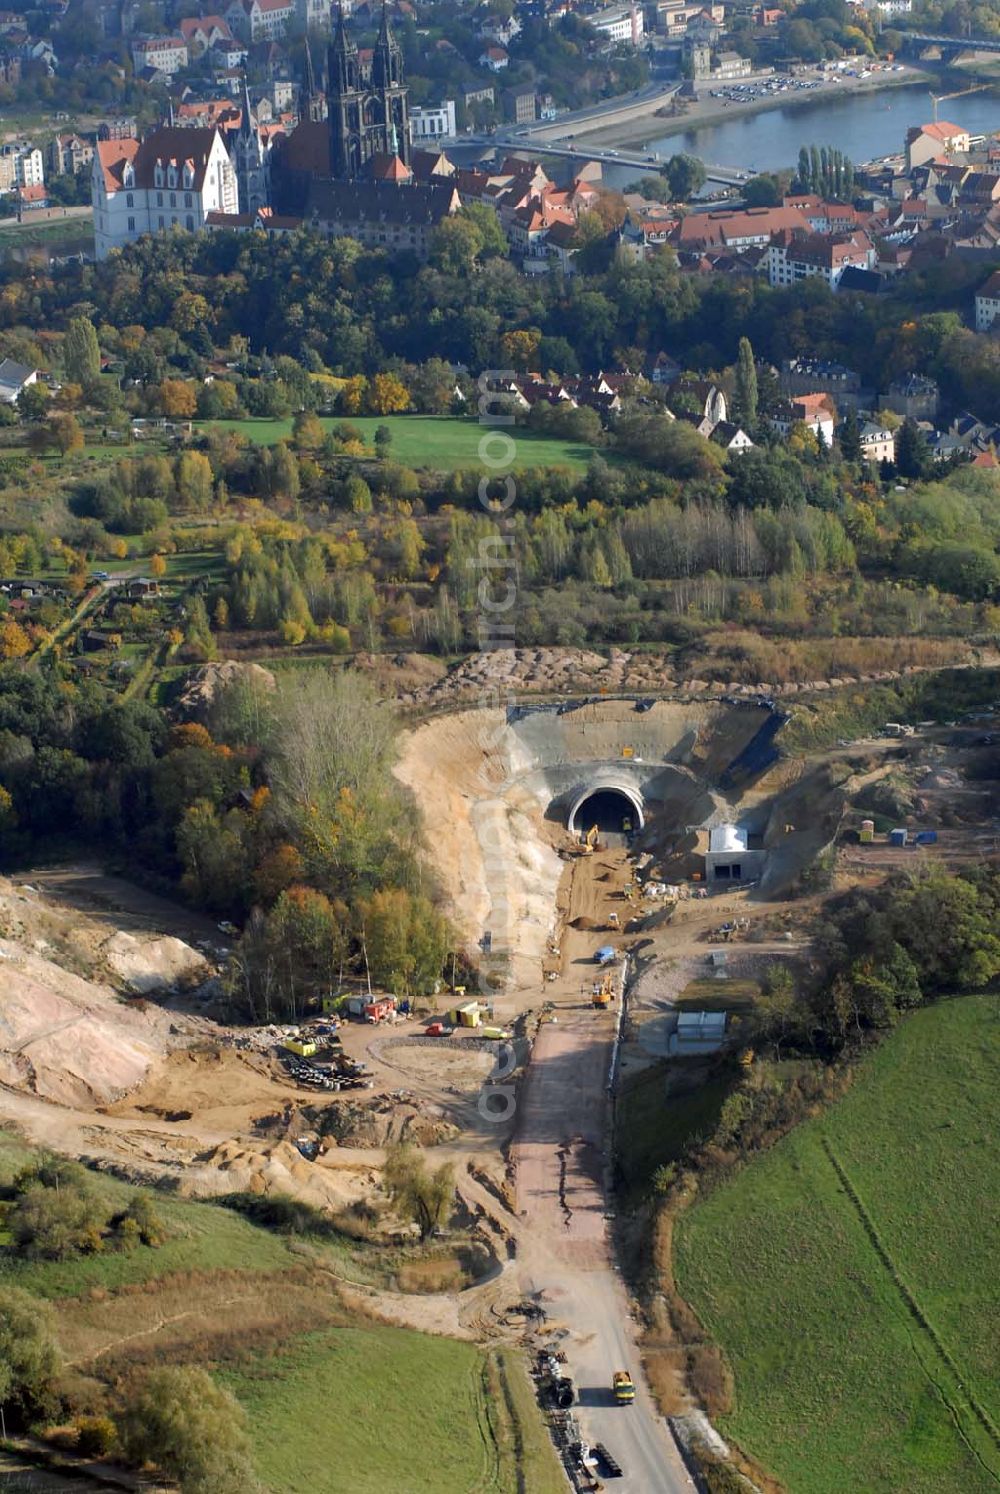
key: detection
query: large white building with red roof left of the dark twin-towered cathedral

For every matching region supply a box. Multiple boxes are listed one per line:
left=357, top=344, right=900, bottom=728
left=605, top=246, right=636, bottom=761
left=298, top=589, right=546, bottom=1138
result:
left=91, top=128, right=239, bottom=260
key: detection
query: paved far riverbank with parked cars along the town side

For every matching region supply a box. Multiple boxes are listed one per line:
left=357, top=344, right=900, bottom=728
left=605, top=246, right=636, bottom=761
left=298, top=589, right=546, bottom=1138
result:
left=538, top=64, right=933, bottom=153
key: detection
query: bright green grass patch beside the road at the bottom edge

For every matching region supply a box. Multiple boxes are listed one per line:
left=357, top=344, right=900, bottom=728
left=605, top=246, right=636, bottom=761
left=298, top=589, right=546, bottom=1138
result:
left=220, top=1325, right=517, bottom=1494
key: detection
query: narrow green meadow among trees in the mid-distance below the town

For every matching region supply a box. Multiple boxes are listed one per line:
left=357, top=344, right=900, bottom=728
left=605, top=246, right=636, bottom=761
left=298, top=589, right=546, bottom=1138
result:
left=202, top=415, right=593, bottom=472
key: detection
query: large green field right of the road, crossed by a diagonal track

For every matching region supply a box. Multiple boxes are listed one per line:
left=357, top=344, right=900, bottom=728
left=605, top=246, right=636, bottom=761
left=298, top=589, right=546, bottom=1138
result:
left=674, top=996, right=1000, bottom=1494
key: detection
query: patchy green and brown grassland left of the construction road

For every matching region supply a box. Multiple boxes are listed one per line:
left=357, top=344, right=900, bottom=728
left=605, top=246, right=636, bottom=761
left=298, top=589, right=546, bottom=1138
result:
left=0, top=1131, right=565, bottom=1494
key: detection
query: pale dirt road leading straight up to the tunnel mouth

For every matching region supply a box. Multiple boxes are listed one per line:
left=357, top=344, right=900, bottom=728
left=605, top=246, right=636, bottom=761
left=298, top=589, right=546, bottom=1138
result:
left=513, top=858, right=695, bottom=1494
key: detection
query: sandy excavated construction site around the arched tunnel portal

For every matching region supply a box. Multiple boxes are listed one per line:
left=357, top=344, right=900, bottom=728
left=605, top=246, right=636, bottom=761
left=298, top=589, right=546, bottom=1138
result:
left=0, top=681, right=1000, bottom=1491
